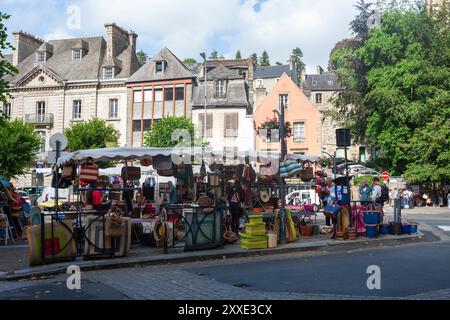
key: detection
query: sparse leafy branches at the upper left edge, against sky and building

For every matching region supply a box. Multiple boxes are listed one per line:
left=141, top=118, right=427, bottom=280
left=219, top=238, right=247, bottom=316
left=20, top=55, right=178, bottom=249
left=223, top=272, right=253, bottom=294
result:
left=0, top=11, right=18, bottom=121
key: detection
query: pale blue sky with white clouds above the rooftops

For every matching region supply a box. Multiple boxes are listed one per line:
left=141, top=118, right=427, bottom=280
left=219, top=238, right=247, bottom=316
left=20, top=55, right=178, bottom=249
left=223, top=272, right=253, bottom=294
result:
left=0, top=0, right=356, bottom=73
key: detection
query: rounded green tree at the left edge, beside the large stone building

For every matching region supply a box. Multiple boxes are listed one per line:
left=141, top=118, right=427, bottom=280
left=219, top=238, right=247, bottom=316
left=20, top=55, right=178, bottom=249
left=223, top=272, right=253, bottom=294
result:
left=0, top=119, right=41, bottom=178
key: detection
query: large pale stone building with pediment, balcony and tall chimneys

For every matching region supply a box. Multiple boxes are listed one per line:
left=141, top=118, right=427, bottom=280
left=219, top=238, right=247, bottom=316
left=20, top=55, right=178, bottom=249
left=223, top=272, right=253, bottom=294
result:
left=4, top=23, right=139, bottom=185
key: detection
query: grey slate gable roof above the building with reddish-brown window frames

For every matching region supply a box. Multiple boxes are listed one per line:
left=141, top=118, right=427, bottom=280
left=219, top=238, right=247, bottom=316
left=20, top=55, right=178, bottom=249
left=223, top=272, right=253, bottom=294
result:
left=127, top=48, right=195, bottom=83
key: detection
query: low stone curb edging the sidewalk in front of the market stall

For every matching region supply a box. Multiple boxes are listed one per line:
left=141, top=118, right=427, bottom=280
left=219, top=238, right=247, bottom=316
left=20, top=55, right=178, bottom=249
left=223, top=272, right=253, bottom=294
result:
left=0, top=231, right=423, bottom=281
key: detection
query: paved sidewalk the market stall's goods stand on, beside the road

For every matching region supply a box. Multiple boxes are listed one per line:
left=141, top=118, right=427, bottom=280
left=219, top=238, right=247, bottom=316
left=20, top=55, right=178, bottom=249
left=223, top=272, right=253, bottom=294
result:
left=0, top=232, right=423, bottom=281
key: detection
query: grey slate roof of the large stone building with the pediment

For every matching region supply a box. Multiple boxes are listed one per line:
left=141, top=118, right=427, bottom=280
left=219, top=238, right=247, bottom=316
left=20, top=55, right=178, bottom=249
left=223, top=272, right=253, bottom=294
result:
left=5, top=37, right=139, bottom=83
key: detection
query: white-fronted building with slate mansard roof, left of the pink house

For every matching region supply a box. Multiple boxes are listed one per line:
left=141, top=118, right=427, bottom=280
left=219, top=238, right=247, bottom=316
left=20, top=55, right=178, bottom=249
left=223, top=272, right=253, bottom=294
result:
left=192, top=60, right=254, bottom=154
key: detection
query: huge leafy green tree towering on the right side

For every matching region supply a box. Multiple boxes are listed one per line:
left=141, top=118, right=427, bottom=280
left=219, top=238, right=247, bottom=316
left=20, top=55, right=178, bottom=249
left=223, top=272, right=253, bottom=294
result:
left=329, top=1, right=450, bottom=183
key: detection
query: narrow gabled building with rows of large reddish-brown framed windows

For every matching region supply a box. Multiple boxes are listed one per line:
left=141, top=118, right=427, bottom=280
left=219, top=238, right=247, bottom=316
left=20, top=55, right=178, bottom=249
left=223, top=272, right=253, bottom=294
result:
left=127, top=48, right=196, bottom=147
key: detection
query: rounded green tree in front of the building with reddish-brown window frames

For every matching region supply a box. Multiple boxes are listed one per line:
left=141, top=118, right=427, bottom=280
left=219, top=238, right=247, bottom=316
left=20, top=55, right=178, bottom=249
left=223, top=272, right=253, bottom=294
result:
left=144, top=116, right=205, bottom=147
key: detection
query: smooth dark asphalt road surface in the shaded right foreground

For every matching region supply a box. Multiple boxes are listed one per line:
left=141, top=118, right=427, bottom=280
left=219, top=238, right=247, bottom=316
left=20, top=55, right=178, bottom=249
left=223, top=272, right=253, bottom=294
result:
left=190, top=243, right=450, bottom=297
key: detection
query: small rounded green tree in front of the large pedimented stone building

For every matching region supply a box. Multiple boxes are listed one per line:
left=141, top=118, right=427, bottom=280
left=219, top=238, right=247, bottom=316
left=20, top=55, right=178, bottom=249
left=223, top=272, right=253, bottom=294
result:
left=64, top=118, right=119, bottom=151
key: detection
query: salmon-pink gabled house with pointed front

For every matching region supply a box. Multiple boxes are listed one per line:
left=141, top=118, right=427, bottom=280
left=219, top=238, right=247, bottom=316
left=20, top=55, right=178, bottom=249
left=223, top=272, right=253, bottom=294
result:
left=254, top=74, right=322, bottom=156
